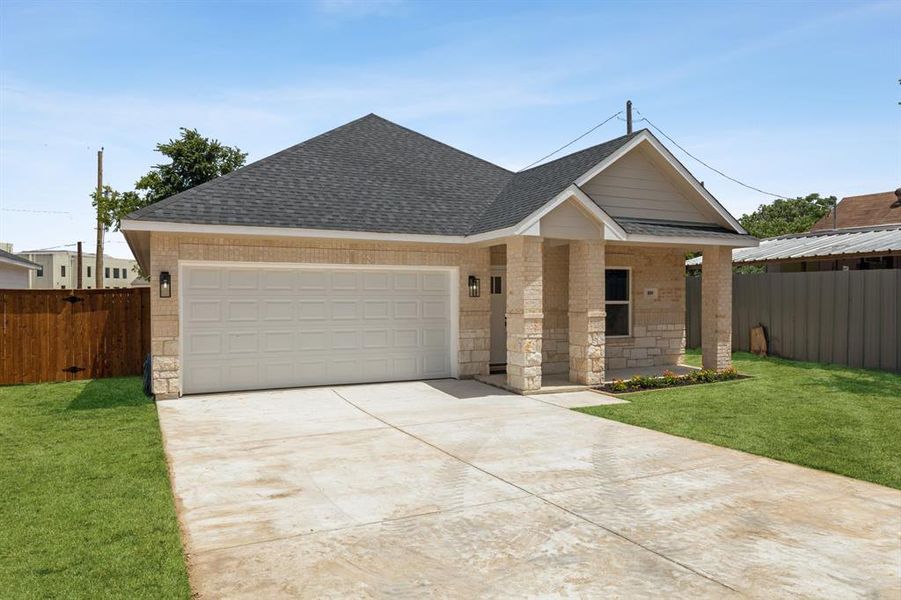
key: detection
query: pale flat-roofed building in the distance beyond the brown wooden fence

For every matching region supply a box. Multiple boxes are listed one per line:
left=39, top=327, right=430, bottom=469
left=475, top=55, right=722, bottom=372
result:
left=19, top=250, right=138, bottom=290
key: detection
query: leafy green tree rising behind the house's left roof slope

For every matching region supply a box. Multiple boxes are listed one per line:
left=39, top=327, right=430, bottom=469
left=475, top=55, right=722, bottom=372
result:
left=91, top=127, right=247, bottom=231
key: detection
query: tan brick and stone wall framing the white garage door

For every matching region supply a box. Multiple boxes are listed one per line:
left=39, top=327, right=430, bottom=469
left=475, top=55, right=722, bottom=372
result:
left=150, top=232, right=488, bottom=399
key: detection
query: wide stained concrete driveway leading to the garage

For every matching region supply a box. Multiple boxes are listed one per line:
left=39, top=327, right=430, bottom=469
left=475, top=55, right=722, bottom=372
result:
left=159, top=380, right=901, bottom=598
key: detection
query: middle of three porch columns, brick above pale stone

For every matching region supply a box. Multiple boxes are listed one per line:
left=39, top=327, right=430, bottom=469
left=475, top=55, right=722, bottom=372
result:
left=569, top=240, right=607, bottom=385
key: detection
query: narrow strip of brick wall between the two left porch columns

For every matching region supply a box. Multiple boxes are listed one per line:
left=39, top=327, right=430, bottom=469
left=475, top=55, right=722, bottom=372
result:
left=541, top=242, right=569, bottom=375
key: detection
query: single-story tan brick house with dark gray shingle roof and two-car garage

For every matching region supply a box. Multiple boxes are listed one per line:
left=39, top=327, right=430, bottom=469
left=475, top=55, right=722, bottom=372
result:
left=122, top=115, right=757, bottom=398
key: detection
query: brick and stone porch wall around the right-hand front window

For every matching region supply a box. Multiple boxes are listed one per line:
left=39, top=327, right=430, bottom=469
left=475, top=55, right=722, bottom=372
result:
left=606, top=245, right=684, bottom=371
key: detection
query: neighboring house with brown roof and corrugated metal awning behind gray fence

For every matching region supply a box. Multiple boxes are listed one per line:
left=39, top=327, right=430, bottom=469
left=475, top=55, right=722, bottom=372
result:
left=685, top=188, right=901, bottom=273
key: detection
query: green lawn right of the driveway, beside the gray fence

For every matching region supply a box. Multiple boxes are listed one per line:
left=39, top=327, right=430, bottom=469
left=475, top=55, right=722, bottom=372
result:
left=576, top=352, right=901, bottom=488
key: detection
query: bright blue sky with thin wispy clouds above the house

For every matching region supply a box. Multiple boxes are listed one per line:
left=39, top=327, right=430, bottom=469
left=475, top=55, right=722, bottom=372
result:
left=0, top=0, right=901, bottom=256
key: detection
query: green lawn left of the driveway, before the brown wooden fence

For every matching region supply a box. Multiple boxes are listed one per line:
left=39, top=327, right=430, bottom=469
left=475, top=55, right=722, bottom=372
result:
left=0, top=377, right=191, bottom=598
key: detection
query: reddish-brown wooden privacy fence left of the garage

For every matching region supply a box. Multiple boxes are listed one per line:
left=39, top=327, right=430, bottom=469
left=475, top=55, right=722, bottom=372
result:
left=0, top=288, right=150, bottom=385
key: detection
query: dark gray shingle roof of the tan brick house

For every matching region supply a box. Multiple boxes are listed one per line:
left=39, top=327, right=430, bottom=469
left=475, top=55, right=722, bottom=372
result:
left=128, top=114, right=747, bottom=239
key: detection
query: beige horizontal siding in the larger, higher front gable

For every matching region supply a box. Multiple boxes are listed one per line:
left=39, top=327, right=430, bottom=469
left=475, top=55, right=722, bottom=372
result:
left=582, top=149, right=716, bottom=223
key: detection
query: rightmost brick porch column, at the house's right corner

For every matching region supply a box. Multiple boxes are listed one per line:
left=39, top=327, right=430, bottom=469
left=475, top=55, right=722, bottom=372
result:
left=701, top=246, right=732, bottom=371
